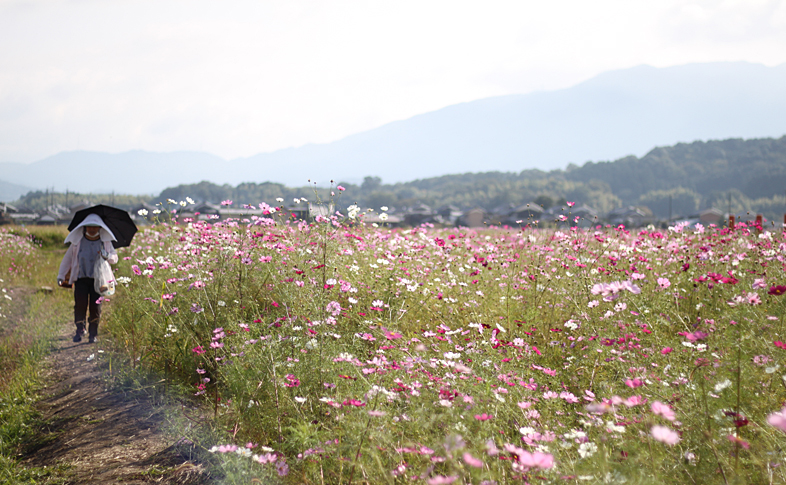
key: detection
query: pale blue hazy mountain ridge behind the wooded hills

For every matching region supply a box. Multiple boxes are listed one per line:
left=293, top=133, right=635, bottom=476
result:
left=0, top=62, right=786, bottom=194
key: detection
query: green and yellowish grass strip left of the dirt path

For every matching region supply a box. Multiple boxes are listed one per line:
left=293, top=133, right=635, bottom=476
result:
left=0, top=227, right=70, bottom=484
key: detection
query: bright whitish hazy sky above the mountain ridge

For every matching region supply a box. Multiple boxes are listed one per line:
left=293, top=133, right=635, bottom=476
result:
left=0, top=0, right=786, bottom=164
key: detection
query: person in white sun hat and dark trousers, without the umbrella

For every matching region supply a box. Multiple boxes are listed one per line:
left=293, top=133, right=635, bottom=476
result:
left=57, top=214, right=117, bottom=343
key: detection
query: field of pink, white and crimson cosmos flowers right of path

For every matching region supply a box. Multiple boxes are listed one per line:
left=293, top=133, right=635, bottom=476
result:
left=102, top=206, right=786, bottom=485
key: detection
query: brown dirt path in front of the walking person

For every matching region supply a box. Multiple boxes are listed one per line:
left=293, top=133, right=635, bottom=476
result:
left=22, top=318, right=208, bottom=484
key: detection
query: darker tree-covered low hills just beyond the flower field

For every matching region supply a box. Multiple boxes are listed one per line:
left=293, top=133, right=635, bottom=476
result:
left=10, top=135, right=786, bottom=221
